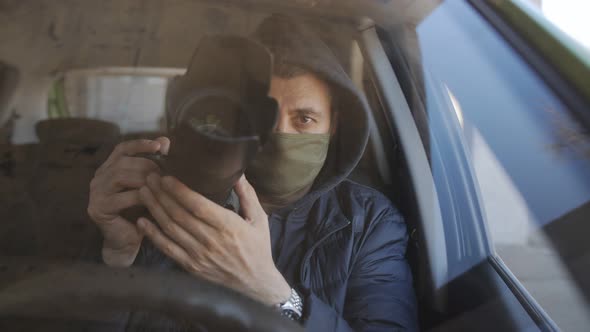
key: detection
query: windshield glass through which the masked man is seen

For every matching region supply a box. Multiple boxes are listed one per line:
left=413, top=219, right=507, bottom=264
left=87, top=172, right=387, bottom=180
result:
left=0, top=1, right=398, bottom=330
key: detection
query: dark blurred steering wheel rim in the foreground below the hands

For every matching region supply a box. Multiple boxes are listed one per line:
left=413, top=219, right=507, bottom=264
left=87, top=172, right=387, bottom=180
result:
left=0, top=258, right=303, bottom=331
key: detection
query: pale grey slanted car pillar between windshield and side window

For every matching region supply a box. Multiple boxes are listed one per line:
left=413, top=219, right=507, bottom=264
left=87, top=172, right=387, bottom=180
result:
left=358, top=26, right=449, bottom=312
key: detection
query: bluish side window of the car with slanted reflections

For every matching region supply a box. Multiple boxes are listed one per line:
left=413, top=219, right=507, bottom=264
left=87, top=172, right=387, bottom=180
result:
left=408, top=2, right=590, bottom=331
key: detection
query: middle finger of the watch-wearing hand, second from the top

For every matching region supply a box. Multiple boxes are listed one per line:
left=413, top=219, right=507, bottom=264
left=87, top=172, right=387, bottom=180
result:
left=147, top=176, right=215, bottom=241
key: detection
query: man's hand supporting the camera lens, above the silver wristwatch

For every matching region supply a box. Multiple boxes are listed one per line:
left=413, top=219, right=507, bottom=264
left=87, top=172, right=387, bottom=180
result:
left=138, top=174, right=291, bottom=304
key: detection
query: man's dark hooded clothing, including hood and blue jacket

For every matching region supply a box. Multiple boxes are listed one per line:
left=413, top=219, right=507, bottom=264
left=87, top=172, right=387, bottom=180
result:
left=127, top=15, right=417, bottom=331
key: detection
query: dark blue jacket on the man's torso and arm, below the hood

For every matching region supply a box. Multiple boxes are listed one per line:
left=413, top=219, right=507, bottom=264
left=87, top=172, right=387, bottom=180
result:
left=271, top=181, right=417, bottom=331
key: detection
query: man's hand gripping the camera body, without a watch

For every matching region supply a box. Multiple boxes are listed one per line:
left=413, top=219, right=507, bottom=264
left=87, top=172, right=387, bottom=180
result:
left=88, top=137, right=170, bottom=266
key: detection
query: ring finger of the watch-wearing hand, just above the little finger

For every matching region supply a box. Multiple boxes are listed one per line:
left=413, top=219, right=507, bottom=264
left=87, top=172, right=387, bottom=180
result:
left=139, top=187, right=206, bottom=253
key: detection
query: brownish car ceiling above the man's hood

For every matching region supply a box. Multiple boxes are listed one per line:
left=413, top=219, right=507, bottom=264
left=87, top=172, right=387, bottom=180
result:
left=0, top=0, right=440, bottom=73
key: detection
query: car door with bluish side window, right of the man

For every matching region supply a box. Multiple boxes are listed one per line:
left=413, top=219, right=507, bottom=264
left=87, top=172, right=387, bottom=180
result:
left=363, top=1, right=590, bottom=331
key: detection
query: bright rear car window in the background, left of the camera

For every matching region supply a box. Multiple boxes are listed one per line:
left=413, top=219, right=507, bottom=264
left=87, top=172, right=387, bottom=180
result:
left=47, top=68, right=183, bottom=134
